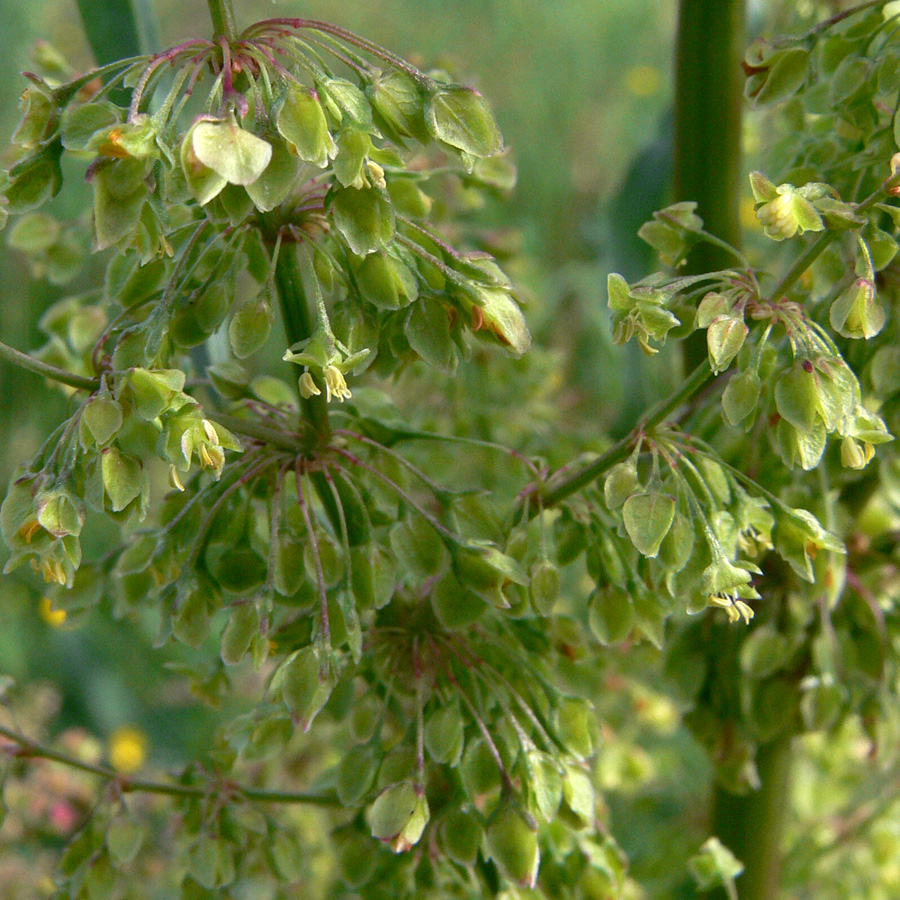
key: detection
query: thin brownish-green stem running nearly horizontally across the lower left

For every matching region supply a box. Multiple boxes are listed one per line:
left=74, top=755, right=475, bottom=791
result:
left=0, top=725, right=338, bottom=806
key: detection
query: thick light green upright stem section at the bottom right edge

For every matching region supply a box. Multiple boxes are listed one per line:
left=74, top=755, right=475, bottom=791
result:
left=712, top=735, right=791, bottom=900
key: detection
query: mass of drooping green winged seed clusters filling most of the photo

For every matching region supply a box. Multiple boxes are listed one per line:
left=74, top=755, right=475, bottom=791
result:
left=0, top=3, right=900, bottom=900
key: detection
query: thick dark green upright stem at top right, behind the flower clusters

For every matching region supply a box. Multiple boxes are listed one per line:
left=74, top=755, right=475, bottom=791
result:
left=673, top=0, right=745, bottom=372
